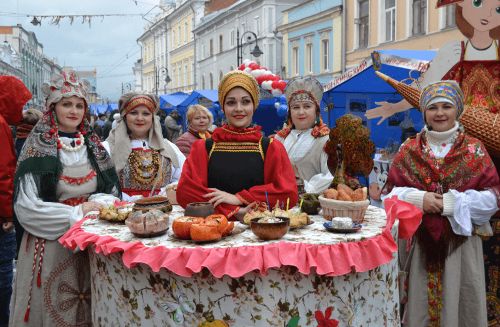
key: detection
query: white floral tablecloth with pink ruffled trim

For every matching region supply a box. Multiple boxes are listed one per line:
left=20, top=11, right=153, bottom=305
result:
left=60, top=206, right=400, bottom=327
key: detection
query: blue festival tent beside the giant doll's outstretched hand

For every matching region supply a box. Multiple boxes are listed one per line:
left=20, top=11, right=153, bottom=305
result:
left=321, top=50, right=436, bottom=147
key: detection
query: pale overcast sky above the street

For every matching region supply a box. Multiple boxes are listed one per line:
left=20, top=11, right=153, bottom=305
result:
left=0, top=0, right=159, bottom=101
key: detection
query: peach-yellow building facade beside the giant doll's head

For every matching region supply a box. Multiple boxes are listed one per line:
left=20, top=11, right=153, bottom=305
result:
left=344, top=0, right=464, bottom=69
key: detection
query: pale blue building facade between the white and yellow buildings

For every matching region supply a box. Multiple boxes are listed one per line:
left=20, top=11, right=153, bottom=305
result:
left=278, top=0, right=344, bottom=83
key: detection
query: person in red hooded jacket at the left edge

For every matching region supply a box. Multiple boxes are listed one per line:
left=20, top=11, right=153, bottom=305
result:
left=0, top=76, right=31, bottom=327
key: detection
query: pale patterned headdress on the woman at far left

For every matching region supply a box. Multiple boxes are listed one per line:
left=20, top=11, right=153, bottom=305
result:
left=42, top=70, right=90, bottom=108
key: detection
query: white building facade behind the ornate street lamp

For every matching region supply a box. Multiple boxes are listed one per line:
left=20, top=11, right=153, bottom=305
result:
left=194, top=0, right=300, bottom=89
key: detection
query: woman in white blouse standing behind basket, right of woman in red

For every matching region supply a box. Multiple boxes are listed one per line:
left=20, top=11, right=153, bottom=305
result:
left=275, top=77, right=333, bottom=193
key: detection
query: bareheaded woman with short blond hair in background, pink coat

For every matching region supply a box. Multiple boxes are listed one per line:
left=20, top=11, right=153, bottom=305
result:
left=175, top=104, right=214, bottom=157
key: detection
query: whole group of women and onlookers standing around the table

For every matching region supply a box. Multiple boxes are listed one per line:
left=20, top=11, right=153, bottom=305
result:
left=0, top=52, right=500, bottom=326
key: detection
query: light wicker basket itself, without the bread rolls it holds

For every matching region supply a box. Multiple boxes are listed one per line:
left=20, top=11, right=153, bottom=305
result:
left=319, top=195, right=370, bottom=224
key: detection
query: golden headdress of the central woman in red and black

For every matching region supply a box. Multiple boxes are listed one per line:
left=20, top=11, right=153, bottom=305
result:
left=219, top=70, right=260, bottom=110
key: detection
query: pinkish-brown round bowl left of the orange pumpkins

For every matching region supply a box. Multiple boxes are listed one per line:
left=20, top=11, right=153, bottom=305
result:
left=125, top=209, right=168, bottom=237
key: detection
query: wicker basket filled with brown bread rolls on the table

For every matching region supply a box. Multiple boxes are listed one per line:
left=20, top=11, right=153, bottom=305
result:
left=319, top=184, right=370, bottom=224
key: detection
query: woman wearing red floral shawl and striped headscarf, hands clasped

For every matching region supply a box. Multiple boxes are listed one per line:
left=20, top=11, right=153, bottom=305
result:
left=386, top=81, right=499, bottom=326
